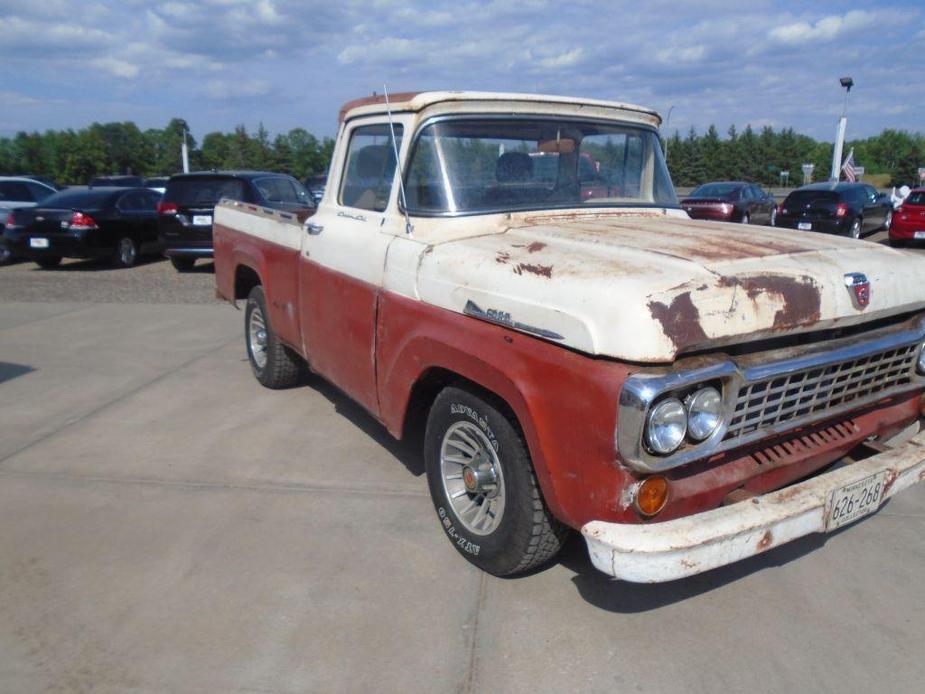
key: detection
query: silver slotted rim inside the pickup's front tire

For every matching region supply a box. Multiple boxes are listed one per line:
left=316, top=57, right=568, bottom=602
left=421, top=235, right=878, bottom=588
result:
left=440, top=422, right=504, bottom=535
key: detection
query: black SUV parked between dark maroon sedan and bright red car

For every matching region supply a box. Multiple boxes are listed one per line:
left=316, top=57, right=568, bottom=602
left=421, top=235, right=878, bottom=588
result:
left=776, top=183, right=893, bottom=239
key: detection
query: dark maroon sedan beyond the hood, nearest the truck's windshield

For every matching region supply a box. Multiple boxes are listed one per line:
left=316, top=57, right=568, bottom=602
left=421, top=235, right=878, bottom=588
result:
left=681, top=181, right=777, bottom=226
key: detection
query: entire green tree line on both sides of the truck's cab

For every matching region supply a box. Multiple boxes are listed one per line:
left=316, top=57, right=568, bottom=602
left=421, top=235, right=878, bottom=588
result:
left=0, top=118, right=925, bottom=186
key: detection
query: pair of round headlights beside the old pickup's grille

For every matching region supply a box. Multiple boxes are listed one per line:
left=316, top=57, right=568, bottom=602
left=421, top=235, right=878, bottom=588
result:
left=645, top=386, right=723, bottom=455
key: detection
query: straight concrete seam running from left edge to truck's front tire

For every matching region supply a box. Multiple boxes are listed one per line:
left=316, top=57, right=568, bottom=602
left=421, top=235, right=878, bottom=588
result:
left=0, top=470, right=429, bottom=498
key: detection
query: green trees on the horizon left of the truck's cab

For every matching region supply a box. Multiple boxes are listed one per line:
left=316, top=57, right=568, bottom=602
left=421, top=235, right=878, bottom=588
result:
left=0, top=118, right=334, bottom=185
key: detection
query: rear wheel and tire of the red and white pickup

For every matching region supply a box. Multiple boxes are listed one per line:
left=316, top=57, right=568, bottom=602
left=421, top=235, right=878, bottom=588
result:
left=244, top=285, right=302, bottom=390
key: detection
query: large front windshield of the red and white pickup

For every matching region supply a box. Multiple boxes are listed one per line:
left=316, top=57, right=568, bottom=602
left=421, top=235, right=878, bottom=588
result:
left=405, top=118, right=678, bottom=214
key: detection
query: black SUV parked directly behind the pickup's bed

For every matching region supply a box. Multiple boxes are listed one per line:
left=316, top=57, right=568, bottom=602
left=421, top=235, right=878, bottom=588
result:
left=157, top=171, right=315, bottom=272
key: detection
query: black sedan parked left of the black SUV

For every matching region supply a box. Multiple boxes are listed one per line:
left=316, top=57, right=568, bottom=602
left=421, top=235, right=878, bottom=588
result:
left=3, top=187, right=161, bottom=268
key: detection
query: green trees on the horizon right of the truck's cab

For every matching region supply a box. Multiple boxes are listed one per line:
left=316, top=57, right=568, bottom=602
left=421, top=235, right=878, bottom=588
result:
left=665, top=125, right=925, bottom=186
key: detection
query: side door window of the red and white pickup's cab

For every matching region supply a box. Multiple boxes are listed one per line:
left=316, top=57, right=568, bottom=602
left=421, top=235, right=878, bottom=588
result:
left=340, top=123, right=402, bottom=212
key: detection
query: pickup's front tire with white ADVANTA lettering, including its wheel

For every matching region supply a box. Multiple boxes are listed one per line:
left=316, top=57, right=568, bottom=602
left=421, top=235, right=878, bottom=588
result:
left=424, top=387, right=568, bottom=576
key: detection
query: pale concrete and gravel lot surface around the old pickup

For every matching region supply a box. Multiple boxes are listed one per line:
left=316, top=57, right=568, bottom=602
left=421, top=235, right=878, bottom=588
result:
left=0, top=235, right=925, bottom=692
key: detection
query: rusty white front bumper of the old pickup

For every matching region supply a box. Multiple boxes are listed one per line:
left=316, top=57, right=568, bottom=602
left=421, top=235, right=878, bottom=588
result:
left=581, top=433, right=925, bottom=583
